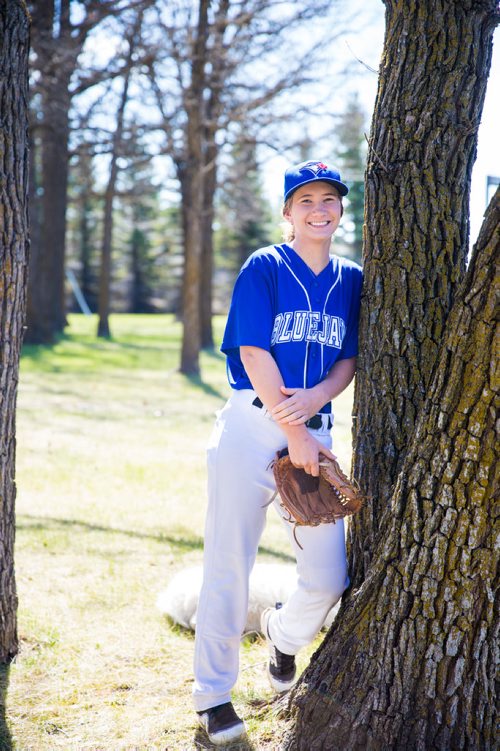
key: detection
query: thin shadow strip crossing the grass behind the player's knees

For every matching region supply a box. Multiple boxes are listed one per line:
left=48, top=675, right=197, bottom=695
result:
left=17, top=514, right=295, bottom=564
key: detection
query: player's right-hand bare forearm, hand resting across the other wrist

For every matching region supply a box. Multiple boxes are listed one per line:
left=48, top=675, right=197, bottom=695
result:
left=271, top=357, right=356, bottom=426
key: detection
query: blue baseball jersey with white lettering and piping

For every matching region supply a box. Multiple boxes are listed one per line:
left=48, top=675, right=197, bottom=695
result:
left=221, top=244, right=362, bottom=412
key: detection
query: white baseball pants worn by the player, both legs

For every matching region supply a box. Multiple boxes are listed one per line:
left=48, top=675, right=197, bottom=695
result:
left=193, top=390, right=349, bottom=711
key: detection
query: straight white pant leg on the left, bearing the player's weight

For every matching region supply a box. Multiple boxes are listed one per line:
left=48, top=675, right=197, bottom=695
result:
left=193, top=391, right=286, bottom=711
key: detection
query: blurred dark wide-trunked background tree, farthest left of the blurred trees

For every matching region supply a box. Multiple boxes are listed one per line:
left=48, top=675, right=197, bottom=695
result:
left=26, top=0, right=150, bottom=343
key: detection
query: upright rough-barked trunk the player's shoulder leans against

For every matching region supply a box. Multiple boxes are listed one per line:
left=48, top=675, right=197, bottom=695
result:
left=349, top=0, right=496, bottom=584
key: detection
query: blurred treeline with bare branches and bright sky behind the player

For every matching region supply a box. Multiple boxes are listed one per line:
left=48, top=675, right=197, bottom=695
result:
left=25, top=0, right=368, bottom=373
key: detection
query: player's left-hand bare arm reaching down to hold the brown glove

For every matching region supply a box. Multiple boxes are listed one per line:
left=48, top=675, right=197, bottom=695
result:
left=240, top=346, right=334, bottom=477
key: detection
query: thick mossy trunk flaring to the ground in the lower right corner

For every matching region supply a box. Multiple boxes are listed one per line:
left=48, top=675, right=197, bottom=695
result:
left=284, top=184, right=500, bottom=751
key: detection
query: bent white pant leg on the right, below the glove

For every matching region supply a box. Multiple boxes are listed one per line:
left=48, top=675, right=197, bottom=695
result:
left=269, top=435, right=349, bottom=655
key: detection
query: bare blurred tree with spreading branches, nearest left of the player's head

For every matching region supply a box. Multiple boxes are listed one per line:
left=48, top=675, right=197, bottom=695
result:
left=151, top=0, right=350, bottom=373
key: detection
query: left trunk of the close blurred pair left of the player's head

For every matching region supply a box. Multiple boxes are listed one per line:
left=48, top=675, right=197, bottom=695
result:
left=179, top=0, right=210, bottom=375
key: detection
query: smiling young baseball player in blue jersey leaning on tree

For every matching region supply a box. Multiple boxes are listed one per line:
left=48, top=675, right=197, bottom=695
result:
left=193, top=161, right=362, bottom=744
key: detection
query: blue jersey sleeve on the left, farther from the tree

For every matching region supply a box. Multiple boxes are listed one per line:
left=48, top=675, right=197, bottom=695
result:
left=221, top=256, right=273, bottom=356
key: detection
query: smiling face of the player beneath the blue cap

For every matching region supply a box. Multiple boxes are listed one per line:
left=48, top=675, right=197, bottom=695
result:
left=283, top=180, right=342, bottom=243
